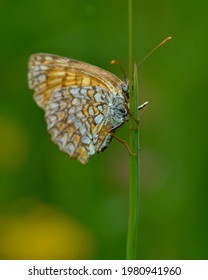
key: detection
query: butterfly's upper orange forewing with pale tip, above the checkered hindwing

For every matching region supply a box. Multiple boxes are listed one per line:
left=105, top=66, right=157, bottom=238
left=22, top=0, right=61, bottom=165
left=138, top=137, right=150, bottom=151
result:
left=28, top=54, right=122, bottom=108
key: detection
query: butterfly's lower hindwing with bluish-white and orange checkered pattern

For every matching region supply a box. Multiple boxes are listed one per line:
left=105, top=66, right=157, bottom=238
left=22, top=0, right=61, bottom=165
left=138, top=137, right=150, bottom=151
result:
left=45, top=86, right=112, bottom=163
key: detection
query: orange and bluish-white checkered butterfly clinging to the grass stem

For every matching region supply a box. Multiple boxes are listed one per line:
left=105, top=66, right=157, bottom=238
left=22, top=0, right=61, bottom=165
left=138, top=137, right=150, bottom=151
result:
left=28, top=53, right=146, bottom=164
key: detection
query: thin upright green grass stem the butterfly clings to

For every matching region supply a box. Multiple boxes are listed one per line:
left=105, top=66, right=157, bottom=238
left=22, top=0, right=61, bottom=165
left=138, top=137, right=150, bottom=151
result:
left=126, top=0, right=139, bottom=260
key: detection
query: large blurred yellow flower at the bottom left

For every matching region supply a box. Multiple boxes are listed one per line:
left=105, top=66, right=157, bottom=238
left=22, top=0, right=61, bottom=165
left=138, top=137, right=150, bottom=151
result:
left=0, top=201, right=94, bottom=259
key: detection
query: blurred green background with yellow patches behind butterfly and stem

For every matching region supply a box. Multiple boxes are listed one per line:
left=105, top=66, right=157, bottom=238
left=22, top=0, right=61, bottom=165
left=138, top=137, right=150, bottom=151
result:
left=0, top=0, right=208, bottom=259
